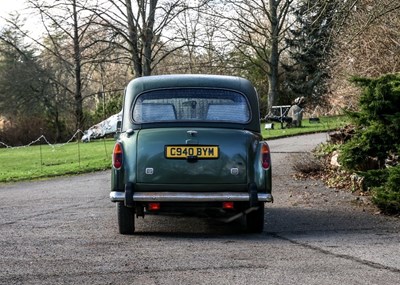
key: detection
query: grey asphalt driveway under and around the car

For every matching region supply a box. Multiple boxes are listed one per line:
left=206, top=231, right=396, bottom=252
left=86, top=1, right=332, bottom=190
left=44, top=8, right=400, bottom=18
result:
left=0, top=134, right=400, bottom=285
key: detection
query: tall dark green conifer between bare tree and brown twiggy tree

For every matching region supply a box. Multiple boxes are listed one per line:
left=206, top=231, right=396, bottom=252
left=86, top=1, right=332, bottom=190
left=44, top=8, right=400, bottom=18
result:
left=283, top=0, right=338, bottom=105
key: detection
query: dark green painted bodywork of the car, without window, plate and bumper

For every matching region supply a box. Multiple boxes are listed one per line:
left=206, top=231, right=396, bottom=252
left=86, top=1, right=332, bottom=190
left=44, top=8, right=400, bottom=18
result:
left=111, top=75, right=271, bottom=193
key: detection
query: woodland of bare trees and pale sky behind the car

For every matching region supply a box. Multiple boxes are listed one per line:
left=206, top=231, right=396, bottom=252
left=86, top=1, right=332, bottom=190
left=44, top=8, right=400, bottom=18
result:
left=0, top=0, right=400, bottom=146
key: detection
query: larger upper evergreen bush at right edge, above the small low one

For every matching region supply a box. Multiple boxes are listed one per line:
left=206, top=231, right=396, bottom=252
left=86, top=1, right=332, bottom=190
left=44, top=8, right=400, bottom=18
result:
left=339, top=74, right=400, bottom=171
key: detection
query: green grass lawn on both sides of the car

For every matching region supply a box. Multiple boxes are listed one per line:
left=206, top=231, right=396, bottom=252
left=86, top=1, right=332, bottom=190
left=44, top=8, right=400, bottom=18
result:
left=0, top=117, right=347, bottom=182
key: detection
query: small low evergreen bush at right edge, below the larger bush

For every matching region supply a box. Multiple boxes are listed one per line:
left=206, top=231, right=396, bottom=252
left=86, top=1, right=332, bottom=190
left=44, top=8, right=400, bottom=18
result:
left=372, top=166, right=400, bottom=214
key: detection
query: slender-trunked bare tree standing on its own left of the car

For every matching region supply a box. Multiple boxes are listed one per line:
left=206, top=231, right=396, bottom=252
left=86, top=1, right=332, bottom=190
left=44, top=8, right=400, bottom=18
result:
left=27, top=0, right=108, bottom=129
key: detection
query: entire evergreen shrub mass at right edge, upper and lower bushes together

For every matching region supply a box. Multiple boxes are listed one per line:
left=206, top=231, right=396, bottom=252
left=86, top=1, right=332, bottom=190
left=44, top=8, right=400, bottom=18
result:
left=332, top=74, right=400, bottom=214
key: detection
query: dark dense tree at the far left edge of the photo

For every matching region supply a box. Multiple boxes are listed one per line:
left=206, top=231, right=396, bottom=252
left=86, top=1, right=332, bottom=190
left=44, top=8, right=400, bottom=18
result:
left=0, top=18, right=70, bottom=143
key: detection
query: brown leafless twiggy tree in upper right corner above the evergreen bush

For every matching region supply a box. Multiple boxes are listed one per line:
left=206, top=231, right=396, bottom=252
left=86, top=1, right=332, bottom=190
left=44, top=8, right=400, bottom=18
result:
left=330, top=0, right=400, bottom=112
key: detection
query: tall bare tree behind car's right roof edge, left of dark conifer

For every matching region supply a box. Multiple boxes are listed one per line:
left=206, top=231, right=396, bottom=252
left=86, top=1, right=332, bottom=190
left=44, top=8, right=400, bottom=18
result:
left=220, top=0, right=293, bottom=113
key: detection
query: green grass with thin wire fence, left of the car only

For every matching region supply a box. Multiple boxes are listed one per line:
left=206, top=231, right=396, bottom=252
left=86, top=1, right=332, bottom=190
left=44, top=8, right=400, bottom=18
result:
left=0, top=130, right=115, bottom=182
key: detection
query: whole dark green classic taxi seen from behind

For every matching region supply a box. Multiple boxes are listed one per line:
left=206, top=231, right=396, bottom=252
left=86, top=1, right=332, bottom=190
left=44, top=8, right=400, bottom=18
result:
left=110, top=75, right=273, bottom=234
